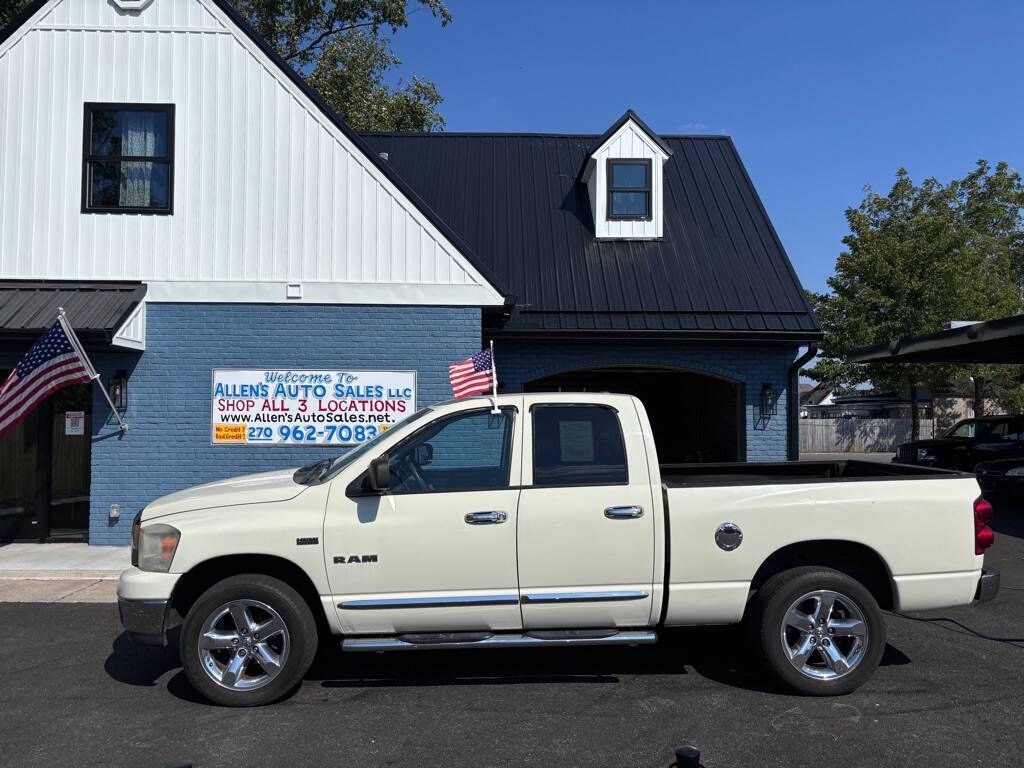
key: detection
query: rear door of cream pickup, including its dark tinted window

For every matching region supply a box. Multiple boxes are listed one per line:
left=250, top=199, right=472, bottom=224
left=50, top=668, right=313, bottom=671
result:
left=518, top=396, right=654, bottom=629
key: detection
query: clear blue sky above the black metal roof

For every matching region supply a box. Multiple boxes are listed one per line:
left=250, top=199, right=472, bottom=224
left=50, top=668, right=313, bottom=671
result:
left=394, top=0, right=1024, bottom=291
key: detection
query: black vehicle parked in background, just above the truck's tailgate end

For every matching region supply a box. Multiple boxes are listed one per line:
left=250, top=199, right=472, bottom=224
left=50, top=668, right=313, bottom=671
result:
left=893, top=415, right=1024, bottom=472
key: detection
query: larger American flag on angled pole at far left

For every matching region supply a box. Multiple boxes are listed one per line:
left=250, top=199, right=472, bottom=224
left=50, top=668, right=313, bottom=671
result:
left=0, top=321, right=92, bottom=435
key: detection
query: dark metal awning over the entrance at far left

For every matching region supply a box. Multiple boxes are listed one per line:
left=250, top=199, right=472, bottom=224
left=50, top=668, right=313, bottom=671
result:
left=0, top=281, right=145, bottom=343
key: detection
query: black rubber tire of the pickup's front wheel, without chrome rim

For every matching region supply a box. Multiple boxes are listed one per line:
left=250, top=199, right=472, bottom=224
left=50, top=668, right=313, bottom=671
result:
left=179, top=573, right=318, bottom=707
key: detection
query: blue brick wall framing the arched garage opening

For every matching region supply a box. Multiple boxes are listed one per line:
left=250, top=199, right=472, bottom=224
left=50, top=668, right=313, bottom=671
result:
left=495, top=342, right=798, bottom=461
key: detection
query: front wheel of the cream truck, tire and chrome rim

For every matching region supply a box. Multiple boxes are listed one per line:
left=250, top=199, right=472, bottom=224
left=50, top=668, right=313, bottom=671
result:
left=180, top=573, right=317, bottom=707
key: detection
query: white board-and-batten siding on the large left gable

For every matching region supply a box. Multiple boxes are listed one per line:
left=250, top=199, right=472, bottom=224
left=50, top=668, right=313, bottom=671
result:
left=0, top=0, right=502, bottom=305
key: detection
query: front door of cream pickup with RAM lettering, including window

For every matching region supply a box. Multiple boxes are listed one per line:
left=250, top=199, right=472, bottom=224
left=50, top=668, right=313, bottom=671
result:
left=324, top=408, right=522, bottom=634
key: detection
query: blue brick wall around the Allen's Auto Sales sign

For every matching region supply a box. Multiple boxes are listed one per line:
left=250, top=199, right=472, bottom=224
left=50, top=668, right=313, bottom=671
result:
left=89, top=304, right=480, bottom=545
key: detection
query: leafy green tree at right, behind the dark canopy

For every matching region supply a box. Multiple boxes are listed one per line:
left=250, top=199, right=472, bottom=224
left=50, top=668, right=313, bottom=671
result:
left=807, top=161, right=1022, bottom=438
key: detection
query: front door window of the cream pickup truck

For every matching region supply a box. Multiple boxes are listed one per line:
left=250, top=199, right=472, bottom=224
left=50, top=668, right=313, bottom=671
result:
left=388, top=408, right=515, bottom=494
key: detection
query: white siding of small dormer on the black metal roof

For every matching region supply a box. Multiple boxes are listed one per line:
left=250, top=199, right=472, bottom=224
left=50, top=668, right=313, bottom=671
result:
left=586, top=120, right=668, bottom=240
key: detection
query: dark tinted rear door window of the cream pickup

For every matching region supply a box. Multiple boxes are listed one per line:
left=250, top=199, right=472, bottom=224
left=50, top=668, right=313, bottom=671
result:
left=534, top=406, right=628, bottom=485
